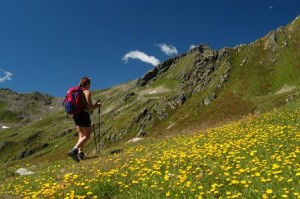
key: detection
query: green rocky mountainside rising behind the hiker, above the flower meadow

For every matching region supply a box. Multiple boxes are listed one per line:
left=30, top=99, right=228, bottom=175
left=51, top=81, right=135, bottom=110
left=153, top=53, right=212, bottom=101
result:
left=0, top=17, right=300, bottom=166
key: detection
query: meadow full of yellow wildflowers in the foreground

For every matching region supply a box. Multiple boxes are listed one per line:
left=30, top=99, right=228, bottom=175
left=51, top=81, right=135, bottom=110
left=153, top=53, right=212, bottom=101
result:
left=0, top=108, right=300, bottom=199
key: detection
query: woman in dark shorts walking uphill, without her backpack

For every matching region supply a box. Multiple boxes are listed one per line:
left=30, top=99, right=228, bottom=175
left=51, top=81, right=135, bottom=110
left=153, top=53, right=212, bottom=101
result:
left=68, top=77, right=101, bottom=162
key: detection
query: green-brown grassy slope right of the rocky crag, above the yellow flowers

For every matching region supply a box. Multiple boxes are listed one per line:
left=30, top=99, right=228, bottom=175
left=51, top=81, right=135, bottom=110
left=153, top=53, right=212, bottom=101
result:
left=155, top=20, right=300, bottom=133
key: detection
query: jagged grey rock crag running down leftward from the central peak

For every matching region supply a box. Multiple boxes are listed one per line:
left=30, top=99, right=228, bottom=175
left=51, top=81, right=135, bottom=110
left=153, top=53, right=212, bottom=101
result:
left=101, top=44, right=231, bottom=146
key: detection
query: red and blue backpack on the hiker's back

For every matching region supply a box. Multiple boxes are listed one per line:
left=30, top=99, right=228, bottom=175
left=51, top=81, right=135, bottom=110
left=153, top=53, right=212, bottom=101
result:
left=62, top=86, right=84, bottom=115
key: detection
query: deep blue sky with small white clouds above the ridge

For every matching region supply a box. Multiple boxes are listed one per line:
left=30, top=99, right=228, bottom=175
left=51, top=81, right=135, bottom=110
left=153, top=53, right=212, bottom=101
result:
left=0, top=0, right=300, bottom=97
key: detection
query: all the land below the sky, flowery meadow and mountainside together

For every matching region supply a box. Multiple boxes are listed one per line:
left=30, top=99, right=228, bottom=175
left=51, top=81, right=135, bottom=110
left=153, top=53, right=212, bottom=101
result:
left=0, top=17, right=300, bottom=199
